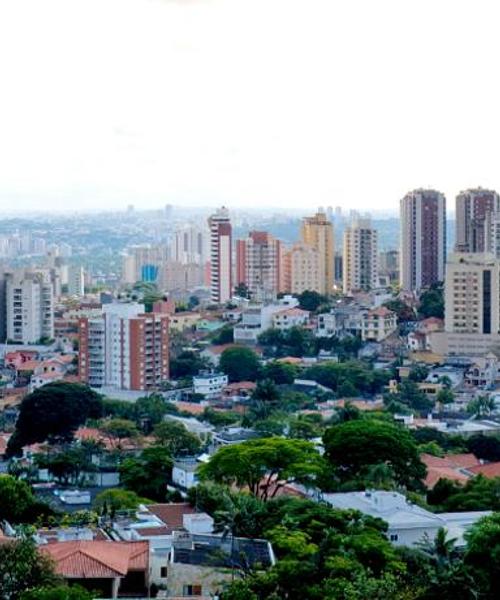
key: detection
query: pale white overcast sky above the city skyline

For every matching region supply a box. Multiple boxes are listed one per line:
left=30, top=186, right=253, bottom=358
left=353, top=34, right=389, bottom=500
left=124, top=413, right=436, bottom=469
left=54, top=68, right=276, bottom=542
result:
left=0, top=0, right=500, bottom=211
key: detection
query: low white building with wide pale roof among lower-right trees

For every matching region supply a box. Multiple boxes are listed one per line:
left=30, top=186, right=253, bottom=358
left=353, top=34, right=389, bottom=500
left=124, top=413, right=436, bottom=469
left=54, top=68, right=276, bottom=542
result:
left=322, top=490, right=491, bottom=546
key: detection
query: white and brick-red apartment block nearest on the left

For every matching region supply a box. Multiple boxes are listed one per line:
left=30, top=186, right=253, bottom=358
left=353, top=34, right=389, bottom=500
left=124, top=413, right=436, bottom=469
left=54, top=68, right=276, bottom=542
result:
left=79, top=303, right=169, bottom=391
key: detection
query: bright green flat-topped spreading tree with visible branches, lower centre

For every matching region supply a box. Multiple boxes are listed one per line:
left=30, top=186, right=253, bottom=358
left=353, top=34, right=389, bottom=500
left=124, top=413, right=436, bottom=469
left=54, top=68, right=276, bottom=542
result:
left=199, top=438, right=323, bottom=500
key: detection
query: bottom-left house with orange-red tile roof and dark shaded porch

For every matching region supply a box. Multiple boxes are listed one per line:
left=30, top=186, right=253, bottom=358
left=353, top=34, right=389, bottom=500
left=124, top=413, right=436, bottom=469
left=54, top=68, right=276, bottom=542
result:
left=39, top=540, right=149, bottom=598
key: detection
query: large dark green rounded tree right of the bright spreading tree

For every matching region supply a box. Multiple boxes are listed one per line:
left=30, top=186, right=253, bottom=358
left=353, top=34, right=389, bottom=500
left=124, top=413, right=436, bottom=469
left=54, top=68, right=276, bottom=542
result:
left=323, top=419, right=426, bottom=489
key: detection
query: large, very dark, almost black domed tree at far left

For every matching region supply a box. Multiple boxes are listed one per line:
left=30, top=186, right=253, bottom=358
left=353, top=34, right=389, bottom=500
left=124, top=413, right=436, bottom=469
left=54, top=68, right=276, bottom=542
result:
left=7, top=382, right=102, bottom=456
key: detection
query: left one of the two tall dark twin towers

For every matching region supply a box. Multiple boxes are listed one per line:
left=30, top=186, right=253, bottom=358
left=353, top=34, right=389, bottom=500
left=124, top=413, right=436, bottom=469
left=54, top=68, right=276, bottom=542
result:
left=400, top=189, right=446, bottom=291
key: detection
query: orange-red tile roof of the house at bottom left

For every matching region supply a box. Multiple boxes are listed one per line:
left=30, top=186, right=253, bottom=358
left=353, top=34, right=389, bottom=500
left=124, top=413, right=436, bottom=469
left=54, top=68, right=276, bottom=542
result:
left=39, top=541, right=149, bottom=579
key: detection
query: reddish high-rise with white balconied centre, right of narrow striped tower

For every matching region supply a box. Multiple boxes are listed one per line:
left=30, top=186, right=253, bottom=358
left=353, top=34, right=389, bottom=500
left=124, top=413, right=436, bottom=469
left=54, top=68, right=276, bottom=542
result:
left=236, top=231, right=283, bottom=300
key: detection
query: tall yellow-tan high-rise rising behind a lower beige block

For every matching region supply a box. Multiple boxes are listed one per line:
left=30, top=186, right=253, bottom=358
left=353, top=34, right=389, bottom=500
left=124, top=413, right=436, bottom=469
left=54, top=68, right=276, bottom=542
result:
left=301, top=212, right=334, bottom=295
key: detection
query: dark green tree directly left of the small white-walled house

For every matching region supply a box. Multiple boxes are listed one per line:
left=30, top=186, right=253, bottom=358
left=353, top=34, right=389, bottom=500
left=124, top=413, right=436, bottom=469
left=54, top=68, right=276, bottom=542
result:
left=119, top=446, right=173, bottom=502
